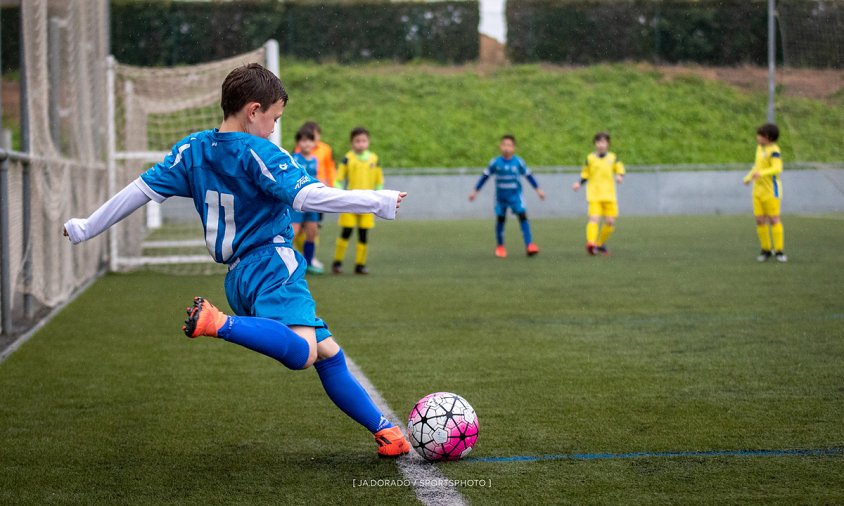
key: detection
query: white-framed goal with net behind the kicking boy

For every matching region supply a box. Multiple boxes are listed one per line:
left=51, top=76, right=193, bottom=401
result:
left=108, top=40, right=280, bottom=274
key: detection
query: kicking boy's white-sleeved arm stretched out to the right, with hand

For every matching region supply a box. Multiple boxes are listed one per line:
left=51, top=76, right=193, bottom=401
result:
left=293, top=184, right=407, bottom=220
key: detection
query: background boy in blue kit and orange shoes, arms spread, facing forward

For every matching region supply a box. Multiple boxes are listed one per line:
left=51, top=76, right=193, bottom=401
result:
left=469, top=134, right=545, bottom=258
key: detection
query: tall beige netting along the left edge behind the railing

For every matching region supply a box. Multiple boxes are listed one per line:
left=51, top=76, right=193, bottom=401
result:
left=0, top=0, right=108, bottom=344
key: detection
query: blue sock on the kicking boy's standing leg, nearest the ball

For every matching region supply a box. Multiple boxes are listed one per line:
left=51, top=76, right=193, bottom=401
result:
left=314, top=349, right=393, bottom=434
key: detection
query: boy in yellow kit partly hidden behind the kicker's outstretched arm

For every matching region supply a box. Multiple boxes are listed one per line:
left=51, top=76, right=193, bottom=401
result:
left=331, top=127, right=384, bottom=274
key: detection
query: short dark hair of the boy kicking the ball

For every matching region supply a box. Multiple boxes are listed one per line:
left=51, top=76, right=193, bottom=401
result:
left=220, top=63, right=287, bottom=119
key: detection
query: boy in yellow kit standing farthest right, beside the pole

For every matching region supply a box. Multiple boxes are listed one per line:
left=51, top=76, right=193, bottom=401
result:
left=744, top=123, right=788, bottom=262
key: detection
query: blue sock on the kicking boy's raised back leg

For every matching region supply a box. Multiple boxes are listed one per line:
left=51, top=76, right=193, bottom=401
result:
left=217, top=316, right=310, bottom=369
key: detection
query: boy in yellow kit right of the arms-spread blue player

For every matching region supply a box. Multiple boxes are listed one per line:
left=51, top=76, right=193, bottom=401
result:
left=571, top=132, right=624, bottom=255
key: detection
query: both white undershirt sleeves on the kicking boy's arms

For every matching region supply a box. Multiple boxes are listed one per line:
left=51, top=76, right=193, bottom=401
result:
left=64, top=178, right=399, bottom=244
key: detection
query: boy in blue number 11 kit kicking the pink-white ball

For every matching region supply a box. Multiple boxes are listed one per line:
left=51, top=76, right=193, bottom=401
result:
left=65, top=63, right=410, bottom=456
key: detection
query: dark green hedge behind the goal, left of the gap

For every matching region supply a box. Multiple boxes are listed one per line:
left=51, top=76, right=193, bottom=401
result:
left=111, top=0, right=478, bottom=65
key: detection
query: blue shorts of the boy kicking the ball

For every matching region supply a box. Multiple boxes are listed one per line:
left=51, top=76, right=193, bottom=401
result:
left=226, top=244, right=331, bottom=342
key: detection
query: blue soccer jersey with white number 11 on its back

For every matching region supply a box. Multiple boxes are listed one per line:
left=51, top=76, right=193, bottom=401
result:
left=141, top=129, right=318, bottom=263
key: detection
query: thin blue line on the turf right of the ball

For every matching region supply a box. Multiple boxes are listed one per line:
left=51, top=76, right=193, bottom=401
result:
left=464, top=447, right=844, bottom=462
